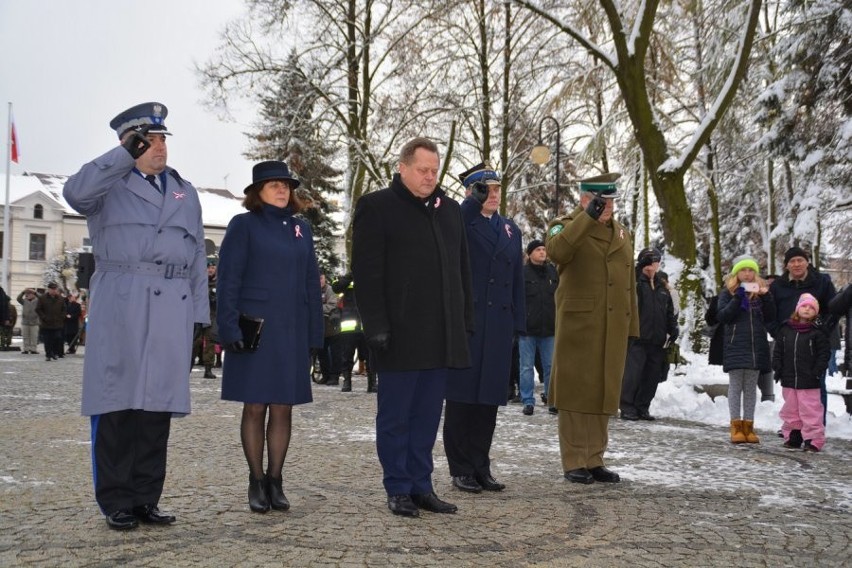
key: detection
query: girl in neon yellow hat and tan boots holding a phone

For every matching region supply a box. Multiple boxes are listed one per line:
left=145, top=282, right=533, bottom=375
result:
left=717, top=255, right=775, bottom=444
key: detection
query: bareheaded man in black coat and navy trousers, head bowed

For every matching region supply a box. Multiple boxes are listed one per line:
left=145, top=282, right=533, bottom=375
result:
left=352, top=138, right=473, bottom=517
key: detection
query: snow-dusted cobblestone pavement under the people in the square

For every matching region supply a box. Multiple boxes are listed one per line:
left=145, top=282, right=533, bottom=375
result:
left=0, top=352, right=852, bottom=567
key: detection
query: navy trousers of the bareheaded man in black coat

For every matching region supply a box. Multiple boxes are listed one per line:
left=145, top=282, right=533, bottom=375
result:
left=376, top=369, right=447, bottom=495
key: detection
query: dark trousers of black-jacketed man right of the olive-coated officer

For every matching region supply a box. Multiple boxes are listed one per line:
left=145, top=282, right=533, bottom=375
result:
left=621, top=341, right=666, bottom=414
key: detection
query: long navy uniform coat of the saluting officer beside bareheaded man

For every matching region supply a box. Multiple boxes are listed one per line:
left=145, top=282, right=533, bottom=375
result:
left=446, top=197, right=526, bottom=405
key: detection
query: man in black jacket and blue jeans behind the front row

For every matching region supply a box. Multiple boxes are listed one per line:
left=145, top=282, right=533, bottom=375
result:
left=518, top=239, right=559, bottom=416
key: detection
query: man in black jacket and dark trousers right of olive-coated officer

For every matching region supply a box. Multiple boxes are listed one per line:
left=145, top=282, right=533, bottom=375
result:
left=620, top=248, right=678, bottom=420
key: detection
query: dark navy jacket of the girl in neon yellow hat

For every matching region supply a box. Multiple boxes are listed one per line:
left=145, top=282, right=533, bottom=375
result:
left=717, top=288, right=775, bottom=373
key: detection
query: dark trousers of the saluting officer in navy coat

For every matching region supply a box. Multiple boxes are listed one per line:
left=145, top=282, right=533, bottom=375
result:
left=444, top=400, right=497, bottom=478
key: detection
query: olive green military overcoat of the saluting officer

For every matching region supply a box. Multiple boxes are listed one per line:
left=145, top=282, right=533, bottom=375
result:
left=545, top=207, right=639, bottom=415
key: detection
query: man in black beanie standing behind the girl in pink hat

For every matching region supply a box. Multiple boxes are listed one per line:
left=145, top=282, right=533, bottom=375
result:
left=766, top=247, right=837, bottom=422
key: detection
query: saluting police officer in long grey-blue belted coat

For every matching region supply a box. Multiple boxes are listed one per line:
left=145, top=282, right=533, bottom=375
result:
left=63, top=102, right=210, bottom=530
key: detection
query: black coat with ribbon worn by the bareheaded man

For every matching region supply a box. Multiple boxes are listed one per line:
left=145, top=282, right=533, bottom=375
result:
left=352, top=174, right=473, bottom=372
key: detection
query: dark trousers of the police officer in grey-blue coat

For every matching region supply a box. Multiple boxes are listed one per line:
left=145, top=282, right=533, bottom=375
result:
left=92, top=410, right=172, bottom=515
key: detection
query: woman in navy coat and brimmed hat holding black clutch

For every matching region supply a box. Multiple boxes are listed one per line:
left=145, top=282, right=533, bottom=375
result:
left=217, top=161, right=323, bottom=513
